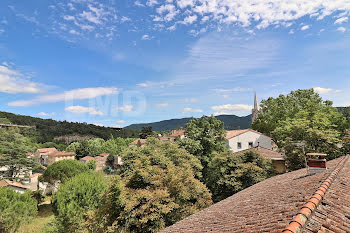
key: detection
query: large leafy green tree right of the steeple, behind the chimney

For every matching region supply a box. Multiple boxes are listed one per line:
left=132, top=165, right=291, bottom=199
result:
left=252, top=89, right=347, bottom=169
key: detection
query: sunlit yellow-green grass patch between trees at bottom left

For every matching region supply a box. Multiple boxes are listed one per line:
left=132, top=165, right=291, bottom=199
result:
left=17, top=204, right=54, bottom=233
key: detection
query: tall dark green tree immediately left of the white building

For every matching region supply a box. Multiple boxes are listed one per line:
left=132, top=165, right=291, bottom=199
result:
left=180, top=116, right=226, bottom=180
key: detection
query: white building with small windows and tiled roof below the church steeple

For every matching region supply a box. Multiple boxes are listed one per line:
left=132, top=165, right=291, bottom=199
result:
left=226, top=129, right=273, bottom=153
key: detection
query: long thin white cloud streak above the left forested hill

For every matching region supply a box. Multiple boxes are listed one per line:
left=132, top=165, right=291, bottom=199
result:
left=8, top=87, right=118, bottom=107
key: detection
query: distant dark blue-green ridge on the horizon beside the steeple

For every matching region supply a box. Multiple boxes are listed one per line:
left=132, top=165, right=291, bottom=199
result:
left=125, top=115, right=251, bottom=131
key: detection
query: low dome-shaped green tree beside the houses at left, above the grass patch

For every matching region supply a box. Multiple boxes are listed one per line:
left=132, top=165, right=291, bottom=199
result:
left=41, top=159, right=89, bottom=183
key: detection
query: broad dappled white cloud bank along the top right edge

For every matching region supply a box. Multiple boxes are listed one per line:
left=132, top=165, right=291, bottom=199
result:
left=150, top=0, right=350, bottom=28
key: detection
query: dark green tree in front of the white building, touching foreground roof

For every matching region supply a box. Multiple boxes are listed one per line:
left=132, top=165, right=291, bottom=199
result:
left=207, top=151, right=273, bottom=202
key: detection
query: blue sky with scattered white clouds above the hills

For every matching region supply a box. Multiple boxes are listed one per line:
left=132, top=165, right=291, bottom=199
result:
left=0, top=0, right=350, bottom=126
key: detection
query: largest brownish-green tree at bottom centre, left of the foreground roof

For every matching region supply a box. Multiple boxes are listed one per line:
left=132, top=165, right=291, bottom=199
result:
left=91, top=138, right=211, bottom=232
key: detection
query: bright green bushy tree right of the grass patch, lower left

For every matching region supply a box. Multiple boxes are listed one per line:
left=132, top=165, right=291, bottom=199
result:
left=52, top=173, right=108, bottom=232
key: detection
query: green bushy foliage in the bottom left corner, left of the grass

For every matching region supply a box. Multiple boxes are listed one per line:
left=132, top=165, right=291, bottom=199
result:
left=0, top=188, right=37, bottom=233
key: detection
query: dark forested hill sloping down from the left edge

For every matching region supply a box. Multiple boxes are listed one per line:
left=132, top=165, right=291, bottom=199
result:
left=0, top=112, right=139, bottom=142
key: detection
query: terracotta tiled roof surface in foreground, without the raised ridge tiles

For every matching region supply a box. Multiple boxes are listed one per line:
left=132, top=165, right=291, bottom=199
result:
left=163, top=156, right=350, bottom=233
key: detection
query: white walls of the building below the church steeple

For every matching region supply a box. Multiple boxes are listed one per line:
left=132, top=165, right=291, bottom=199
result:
left=228, top=131, right=272, bottom=153
